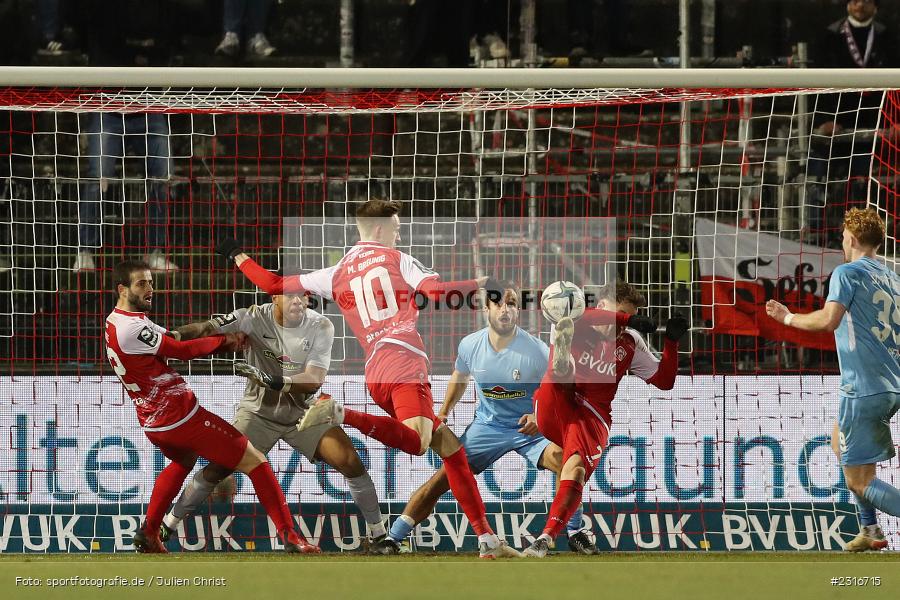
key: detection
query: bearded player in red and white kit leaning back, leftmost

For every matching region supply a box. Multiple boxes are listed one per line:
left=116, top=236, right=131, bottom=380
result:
left=105, top=261, right=319, bottom=553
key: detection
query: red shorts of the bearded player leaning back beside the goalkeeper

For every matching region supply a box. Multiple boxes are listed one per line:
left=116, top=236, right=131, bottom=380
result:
left=144, top=406, right=247, bottom=470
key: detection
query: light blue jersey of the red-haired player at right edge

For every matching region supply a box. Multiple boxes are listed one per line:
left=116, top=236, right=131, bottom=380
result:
left=826, top=257, right=900, bottom=398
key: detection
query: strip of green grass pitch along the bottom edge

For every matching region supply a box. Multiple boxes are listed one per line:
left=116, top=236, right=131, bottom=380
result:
left=0, top=552, right=900, bottom=600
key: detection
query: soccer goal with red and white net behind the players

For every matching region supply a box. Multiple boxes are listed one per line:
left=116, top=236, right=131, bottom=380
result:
left=0, top=69, right=900, bottom=552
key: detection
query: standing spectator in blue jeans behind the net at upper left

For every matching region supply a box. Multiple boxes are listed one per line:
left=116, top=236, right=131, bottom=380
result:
left=72, top=0, right=178, bottom=271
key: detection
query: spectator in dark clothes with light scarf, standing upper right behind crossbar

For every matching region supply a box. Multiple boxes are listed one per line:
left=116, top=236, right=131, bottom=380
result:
left=807, top=0, right=898, bottom=245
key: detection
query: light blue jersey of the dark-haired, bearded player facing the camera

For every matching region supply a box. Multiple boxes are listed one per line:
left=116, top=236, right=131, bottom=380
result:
left=456, top=327, right=550, bottom=429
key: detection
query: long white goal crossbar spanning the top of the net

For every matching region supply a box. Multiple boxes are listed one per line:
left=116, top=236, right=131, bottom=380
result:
left=0, top=67, right=900, bottom=89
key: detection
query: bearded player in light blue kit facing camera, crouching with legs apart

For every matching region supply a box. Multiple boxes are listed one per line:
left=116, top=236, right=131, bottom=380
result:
left=374, top=282, right=597, bottom=554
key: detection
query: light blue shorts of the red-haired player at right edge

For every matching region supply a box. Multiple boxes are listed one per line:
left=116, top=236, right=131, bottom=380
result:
left=838, top=392, right=900, bottom=465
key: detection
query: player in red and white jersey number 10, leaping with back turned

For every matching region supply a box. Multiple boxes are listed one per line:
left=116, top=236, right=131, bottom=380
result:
left=216, top=200, right=521, bottom=558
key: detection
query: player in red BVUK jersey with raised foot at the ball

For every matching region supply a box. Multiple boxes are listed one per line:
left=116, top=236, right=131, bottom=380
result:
left=524, top=281, right=688, bottom=558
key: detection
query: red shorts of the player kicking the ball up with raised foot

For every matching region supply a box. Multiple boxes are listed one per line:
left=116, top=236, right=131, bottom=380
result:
left=534, top=372, right=609, bottom=478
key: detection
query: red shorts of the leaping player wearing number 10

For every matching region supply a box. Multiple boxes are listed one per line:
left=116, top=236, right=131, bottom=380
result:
left=366, top=344, right=441, bottom=428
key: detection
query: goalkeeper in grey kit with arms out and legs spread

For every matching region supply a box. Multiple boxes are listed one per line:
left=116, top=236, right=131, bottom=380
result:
left=160, top=294, right=386, bottom=541
